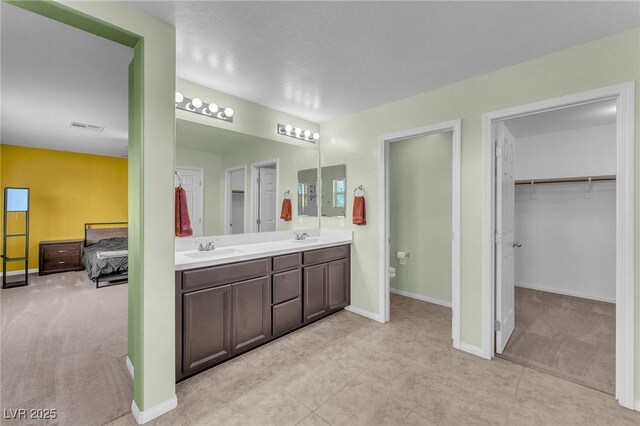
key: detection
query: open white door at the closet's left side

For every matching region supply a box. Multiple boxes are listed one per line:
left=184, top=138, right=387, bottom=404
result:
left=496, top=122, right=515, bottom=354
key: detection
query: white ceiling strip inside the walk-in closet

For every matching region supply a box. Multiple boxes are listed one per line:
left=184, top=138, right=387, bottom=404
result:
left=505, top=99, right=616, bottom=138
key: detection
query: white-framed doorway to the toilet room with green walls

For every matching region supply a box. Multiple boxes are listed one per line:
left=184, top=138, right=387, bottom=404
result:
left=379, top=120, right=462, bottom=348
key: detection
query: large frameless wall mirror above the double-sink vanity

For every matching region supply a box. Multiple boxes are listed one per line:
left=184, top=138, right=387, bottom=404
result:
left=175, top=120, right=320, bottom=236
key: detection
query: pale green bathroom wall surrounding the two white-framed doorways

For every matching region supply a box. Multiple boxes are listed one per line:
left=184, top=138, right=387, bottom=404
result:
left=320, top=28, right=640, bottom=394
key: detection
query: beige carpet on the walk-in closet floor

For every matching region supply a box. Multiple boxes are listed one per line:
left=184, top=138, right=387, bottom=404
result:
left=502, top=287, right=616, bottom=395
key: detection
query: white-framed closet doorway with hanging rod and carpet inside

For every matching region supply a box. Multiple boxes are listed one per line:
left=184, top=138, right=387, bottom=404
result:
left=484, top=85, right=634, bottom=408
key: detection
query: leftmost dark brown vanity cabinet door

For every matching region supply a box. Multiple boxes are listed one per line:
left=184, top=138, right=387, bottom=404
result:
left=182, top=285, right=231, bottom=374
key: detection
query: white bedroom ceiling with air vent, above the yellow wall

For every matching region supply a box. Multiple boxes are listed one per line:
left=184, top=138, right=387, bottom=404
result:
left=0, top=2, right=133, bottom=156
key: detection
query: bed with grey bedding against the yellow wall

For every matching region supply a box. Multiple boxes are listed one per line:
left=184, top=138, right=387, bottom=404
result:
left=82, top=222, right=129, bottom=288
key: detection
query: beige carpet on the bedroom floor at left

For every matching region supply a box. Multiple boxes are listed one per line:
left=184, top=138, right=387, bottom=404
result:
left=0, top=271, right=133, bottom=425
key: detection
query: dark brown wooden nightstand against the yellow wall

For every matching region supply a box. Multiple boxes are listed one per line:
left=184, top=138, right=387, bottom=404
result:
left=38, top=240, right=84, bottom=275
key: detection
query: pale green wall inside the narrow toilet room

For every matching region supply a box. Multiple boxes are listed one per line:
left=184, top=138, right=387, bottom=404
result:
left=389, top=132, right=453, bottom=303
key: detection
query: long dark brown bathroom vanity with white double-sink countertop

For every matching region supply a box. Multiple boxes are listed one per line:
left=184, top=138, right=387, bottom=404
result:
left=176, top=233, right=351, bottom=381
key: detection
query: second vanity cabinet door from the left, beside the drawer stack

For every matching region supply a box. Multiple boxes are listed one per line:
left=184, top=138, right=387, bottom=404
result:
left=231, top=277, right=271, bottom=355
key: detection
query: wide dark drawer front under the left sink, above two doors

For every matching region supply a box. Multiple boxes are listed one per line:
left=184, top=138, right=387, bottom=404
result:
left=182, top=259, right=269, bottom=290
